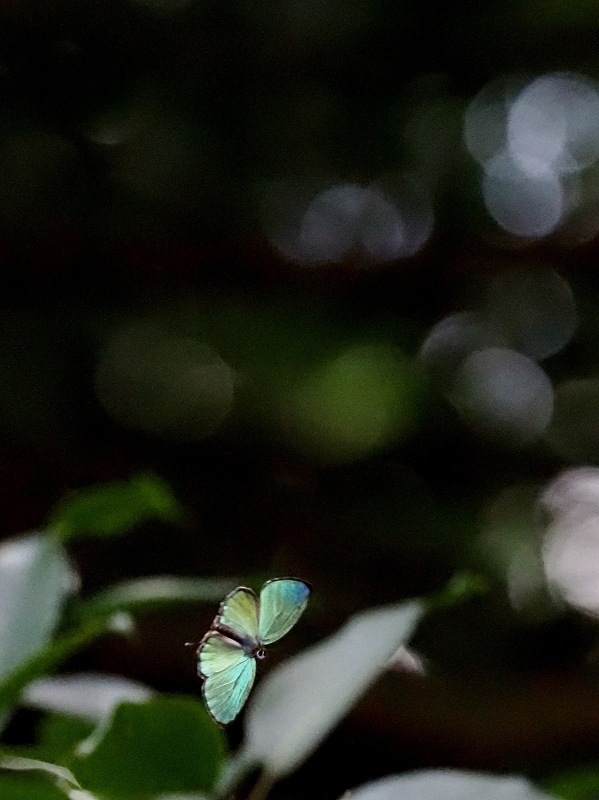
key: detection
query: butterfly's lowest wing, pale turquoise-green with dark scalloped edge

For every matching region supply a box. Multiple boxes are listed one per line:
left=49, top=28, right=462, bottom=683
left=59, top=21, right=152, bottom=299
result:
left=198, top=631, right=256, bottom=725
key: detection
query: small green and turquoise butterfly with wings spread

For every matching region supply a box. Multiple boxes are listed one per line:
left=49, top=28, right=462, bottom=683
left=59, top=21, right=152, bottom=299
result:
left=197, top=578, right=310, bottom=725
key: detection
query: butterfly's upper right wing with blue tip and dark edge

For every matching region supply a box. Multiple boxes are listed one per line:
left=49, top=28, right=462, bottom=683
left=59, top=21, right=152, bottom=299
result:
left=258, top=578, right=310, bottom=645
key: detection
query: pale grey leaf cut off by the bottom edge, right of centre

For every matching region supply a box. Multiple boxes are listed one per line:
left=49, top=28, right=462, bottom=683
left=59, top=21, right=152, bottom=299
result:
left=342, top=769, right=549, bottom=800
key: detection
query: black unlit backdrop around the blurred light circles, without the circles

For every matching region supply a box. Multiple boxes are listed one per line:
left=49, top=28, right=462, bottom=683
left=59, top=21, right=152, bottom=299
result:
left=0, top=0, right=599, bottom=797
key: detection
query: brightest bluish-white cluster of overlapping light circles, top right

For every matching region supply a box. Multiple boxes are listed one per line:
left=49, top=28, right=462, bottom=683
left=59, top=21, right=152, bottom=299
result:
left=464, top=73, right=599, bottom=239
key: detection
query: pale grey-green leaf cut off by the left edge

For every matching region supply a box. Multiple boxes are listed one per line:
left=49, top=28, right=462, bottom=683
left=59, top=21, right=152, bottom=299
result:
left=0, top=533, right=74, bottom=728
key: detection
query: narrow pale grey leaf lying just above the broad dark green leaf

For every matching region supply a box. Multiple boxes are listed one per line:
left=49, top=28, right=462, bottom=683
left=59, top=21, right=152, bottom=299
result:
left=21, top=672, right=154, bottom=724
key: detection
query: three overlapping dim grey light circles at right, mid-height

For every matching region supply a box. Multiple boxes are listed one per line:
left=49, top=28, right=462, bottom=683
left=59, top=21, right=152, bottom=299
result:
left=419, top=265, right=580, bottom=445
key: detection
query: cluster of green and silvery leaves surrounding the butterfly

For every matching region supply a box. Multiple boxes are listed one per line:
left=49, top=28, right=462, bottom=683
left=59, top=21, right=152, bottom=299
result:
left=0, top=480, right=536, bottom=800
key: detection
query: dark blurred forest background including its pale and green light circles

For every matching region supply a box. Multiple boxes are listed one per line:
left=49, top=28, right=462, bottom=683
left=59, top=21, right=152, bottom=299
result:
left=0, top=0, right=599, bottom=800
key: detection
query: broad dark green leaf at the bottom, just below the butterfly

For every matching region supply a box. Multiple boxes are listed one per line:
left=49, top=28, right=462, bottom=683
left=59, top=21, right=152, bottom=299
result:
left=71, top=697, right=225, bottom=800
